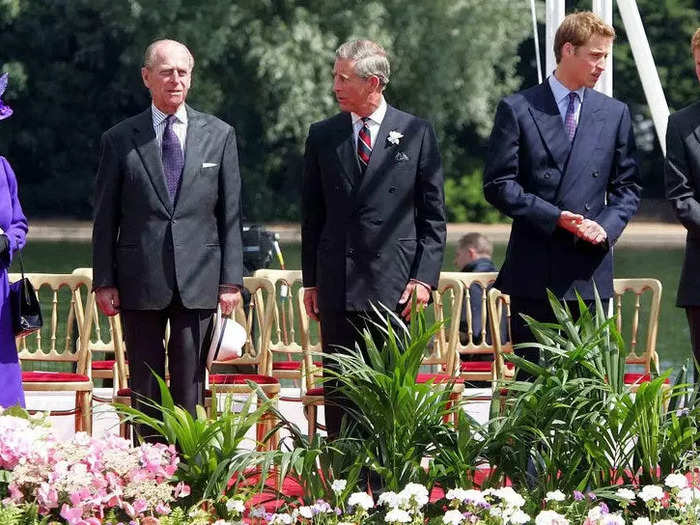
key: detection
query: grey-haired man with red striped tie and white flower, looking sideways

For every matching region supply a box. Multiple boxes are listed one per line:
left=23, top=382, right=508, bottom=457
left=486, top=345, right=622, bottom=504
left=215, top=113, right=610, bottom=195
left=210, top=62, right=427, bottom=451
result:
left=302, top=40, right=445, bottom=437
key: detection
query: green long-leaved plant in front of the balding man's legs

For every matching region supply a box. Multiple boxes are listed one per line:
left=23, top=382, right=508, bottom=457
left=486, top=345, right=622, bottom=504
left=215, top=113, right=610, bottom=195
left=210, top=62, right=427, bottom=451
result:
left=113, top=376, right=272, bottom=505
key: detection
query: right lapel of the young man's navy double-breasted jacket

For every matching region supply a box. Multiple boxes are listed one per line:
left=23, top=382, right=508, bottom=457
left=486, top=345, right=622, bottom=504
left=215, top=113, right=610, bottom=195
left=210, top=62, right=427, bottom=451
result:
left=557, top=88, right=604, bottom=202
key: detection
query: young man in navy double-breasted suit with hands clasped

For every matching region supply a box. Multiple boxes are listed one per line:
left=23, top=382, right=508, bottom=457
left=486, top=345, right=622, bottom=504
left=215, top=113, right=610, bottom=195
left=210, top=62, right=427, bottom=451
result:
left=484, top=12, right=640, bottom=379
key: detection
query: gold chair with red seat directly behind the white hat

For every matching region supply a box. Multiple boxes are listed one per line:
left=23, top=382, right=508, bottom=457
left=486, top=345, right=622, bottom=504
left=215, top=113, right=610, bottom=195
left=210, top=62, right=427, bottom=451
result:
left=207, top=277, right=280, bottom=448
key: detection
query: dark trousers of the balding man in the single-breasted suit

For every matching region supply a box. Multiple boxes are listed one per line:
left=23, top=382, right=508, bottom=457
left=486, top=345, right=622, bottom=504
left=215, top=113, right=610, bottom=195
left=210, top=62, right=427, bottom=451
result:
left=121, top=293, right=214, bottom=437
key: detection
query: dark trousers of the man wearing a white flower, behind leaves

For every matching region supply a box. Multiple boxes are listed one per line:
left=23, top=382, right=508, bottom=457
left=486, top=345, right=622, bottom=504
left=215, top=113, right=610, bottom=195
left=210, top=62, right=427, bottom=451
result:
left=321, top=312, right=401, bottom=439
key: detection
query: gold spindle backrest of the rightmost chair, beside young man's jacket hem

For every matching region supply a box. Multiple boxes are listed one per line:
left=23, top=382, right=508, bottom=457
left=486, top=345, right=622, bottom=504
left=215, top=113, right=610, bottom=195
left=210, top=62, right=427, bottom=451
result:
left=613, top=278, right=662, bottom=374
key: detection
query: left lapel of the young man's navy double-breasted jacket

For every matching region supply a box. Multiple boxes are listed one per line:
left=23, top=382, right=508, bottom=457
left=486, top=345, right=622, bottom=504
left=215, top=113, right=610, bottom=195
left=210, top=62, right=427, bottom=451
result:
left=529, top=80, right=571, bottom=173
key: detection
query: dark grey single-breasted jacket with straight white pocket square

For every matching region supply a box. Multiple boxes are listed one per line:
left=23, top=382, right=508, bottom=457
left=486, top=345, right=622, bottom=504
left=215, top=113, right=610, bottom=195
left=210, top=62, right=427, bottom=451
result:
left=92, top=107, right=243, bottom=310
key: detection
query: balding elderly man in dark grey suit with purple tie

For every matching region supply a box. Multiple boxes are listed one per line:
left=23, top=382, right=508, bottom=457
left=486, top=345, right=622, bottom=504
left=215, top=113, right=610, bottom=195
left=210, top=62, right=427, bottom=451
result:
left=93, top=36, right=242, bottom=430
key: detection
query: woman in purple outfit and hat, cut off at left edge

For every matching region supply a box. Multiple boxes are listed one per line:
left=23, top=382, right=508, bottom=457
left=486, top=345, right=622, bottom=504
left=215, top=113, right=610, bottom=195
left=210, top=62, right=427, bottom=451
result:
left=0, top=73, right=27, bottom=408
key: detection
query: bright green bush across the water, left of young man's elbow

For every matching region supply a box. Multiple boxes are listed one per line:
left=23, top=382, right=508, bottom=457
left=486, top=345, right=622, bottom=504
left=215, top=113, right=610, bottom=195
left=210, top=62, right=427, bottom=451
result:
left=445, top=169, right=505, bottom=223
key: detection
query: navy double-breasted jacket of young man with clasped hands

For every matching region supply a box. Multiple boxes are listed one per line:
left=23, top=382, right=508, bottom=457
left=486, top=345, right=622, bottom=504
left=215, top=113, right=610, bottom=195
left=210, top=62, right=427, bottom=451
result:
left=484, top=81, right=640, bottom=300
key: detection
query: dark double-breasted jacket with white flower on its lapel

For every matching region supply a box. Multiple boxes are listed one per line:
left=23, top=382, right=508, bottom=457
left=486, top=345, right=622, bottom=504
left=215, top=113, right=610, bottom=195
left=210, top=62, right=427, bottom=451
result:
left=302, top=106, right=446, bottom=312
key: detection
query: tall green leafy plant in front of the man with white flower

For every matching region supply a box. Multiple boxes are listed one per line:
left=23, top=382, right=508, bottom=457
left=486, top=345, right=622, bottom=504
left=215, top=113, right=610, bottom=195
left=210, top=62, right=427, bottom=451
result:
left=326, top=298, right=460, bottom=491
